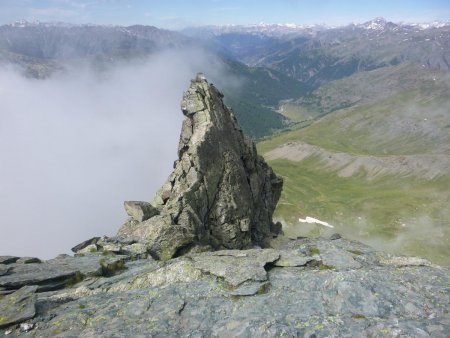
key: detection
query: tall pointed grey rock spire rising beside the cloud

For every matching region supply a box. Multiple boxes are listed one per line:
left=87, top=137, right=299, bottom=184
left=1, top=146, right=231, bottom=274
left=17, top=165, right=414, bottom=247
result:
left=118, top=74, right=283, bottom=260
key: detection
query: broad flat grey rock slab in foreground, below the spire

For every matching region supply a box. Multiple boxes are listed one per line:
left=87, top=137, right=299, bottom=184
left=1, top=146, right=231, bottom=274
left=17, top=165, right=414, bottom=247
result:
left=0, top=238, right=450, bottom=338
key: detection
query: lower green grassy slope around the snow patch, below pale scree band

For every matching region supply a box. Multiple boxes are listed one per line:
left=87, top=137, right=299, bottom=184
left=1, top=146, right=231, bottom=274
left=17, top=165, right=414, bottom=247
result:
left=269, top=158, right=450, bottom=265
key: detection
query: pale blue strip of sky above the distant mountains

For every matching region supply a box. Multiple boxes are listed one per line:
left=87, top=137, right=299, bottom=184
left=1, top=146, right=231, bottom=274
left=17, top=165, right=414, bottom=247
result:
left=0, top=0, right=450, bottom=29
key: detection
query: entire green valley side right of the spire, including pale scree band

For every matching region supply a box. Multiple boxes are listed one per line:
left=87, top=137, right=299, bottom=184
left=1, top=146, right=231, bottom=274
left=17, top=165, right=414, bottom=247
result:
left=258, top=53, right=450, bottom=265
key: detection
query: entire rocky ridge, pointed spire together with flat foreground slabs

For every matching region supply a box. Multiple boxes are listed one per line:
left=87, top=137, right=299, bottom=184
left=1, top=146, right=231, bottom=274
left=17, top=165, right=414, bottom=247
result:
left=0, top=75, right=450, bottom=337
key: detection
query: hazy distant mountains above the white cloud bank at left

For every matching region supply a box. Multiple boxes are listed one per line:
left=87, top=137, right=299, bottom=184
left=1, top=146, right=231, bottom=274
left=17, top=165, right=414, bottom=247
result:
left=0, top=23, right=190, bottom=64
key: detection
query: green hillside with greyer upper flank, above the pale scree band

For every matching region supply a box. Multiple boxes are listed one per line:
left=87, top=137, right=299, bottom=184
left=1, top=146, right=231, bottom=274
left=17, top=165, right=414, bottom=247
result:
left=260, top=65, right=450, bottom=155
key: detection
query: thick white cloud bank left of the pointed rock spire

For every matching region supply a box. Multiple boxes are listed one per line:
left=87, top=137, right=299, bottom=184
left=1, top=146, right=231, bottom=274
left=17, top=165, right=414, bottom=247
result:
left=0, top=50, right=232, bottom=258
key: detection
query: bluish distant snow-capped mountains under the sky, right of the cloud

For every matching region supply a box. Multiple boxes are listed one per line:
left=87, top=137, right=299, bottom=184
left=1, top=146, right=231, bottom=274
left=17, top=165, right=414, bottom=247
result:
left=190, top=18, right=450, bottom=88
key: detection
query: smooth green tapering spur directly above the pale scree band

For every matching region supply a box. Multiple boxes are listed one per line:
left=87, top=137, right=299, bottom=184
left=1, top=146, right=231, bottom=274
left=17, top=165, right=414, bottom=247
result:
left=274, top=89, right=450, bottom=155
